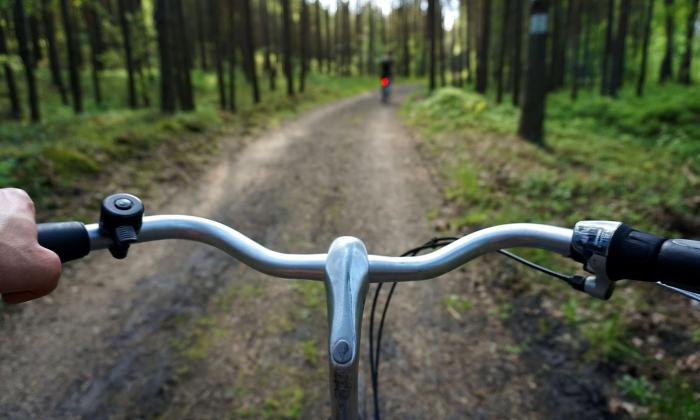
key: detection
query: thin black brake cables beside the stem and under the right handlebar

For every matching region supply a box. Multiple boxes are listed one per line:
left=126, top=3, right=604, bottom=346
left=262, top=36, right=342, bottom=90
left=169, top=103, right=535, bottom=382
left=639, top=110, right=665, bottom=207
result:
left=369, top=236, right=586, bottom=420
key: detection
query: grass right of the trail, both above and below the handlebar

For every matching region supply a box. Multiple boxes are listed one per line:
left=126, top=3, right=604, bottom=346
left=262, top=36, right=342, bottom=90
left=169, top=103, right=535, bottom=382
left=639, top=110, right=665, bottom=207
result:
left=402, top=84, right=700, bottom=418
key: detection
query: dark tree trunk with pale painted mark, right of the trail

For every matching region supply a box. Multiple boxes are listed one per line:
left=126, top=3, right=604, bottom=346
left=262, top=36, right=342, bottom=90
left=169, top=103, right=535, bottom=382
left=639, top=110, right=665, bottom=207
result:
left=518, top=0, right=547, bottom=144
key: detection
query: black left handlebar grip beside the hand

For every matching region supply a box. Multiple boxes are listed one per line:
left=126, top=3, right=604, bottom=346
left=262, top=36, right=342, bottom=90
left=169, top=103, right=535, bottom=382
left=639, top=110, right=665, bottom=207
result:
left=37, top=222, right=90, bottom=262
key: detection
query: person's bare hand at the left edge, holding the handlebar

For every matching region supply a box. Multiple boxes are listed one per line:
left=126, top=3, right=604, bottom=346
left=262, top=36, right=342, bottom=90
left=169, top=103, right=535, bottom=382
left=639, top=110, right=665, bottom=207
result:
left=0, top=188, right=61, bottom=304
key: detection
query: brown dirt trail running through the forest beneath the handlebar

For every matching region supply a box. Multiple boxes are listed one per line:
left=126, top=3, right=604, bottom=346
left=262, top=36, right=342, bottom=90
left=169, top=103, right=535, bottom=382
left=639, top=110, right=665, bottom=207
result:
left=0, top=89, right=604, bottom=419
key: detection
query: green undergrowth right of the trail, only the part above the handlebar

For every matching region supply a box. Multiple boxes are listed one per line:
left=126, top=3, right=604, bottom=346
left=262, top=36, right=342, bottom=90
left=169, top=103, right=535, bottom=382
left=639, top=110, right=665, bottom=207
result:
left=403, top=86, right=700, bottom=234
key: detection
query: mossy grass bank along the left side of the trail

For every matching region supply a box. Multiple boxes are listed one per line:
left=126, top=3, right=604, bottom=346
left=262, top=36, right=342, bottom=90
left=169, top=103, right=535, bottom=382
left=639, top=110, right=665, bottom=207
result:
left=0, top=70, right=375, bottom=219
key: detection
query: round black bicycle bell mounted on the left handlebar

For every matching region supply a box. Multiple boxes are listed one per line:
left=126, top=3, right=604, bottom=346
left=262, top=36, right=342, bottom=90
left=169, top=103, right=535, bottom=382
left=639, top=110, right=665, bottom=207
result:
left=100, top=193, right=144, bottom=259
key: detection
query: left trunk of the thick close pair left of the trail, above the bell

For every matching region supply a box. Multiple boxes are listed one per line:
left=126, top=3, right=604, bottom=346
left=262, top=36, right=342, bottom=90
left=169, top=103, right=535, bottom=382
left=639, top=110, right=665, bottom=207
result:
left=154, top=0, right=177, bottom=114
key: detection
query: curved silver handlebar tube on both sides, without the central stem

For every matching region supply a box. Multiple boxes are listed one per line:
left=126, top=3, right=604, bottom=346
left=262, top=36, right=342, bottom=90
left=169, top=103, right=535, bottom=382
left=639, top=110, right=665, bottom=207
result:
left=87, top=215, right=573, bottom=283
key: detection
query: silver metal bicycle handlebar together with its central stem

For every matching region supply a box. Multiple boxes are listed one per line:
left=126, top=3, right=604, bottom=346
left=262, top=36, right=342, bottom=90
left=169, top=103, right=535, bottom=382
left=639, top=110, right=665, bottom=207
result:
left=86, top=216, right=573, bottom=420
